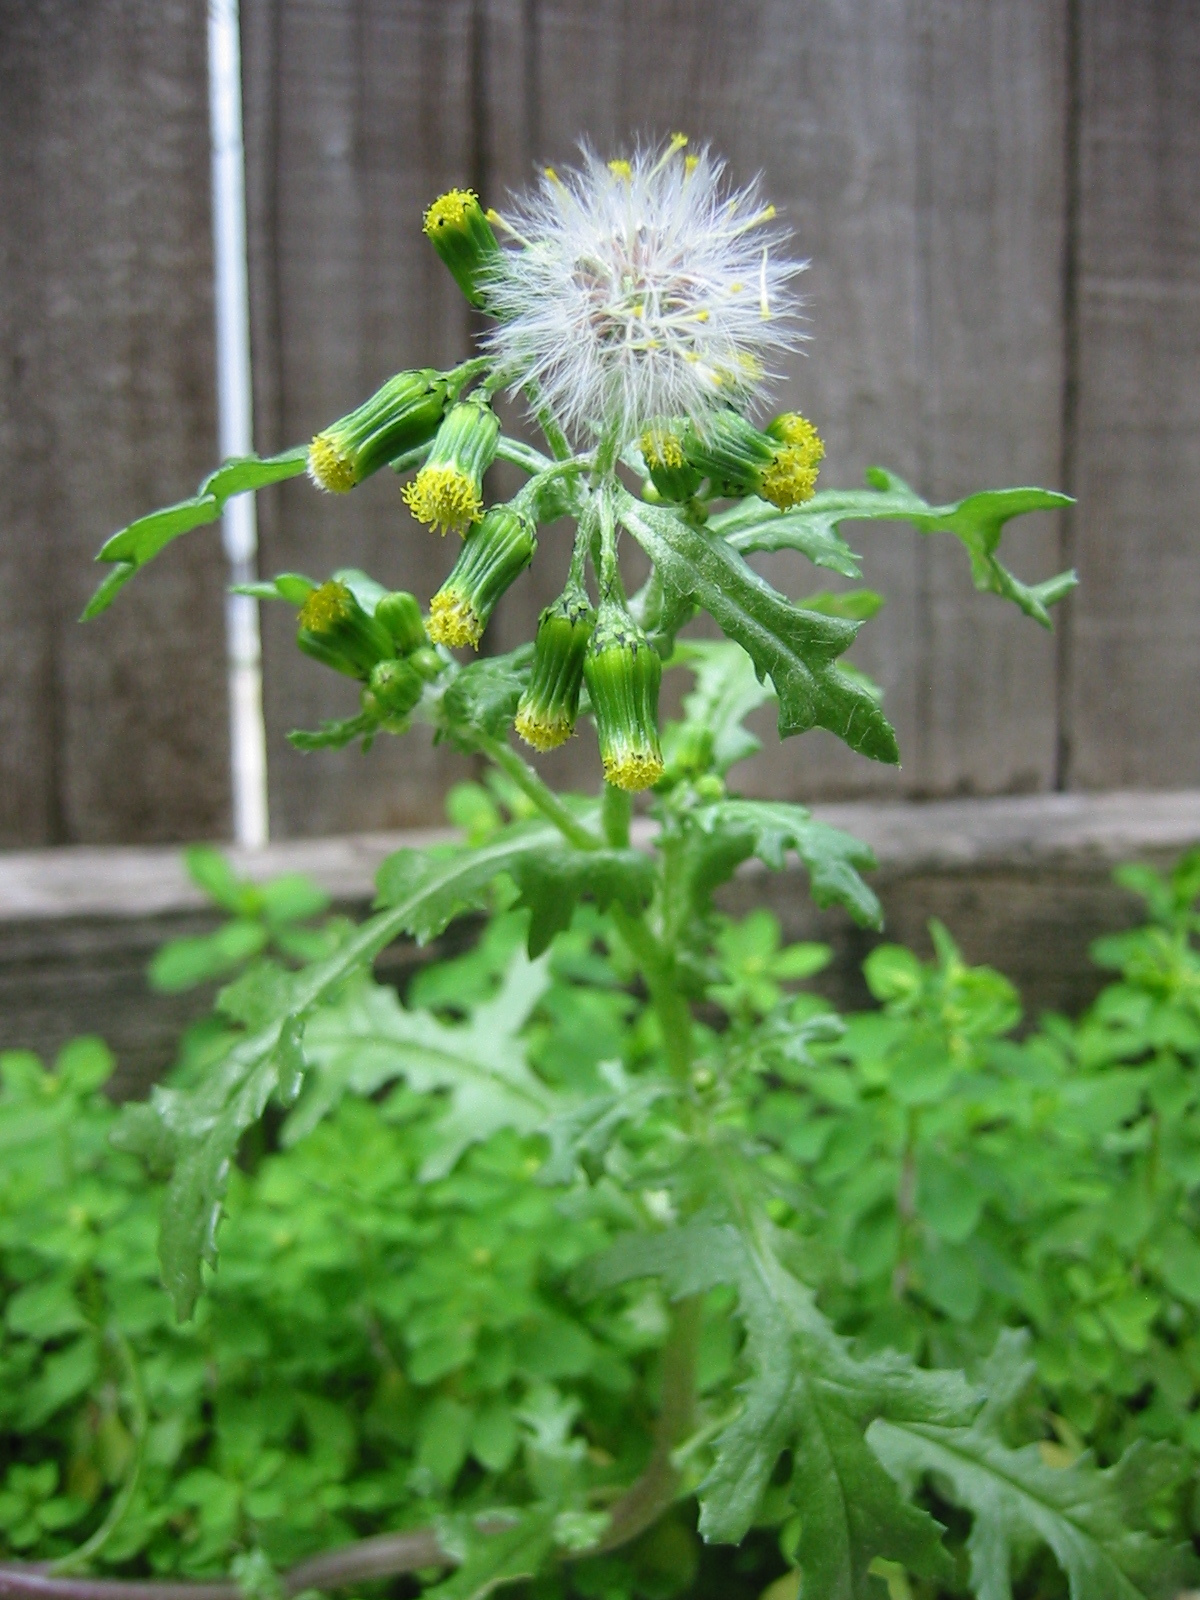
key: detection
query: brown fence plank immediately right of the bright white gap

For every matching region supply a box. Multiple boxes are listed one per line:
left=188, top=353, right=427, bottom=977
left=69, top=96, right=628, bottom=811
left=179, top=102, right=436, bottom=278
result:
left=243, top=0, right=472, bottom=837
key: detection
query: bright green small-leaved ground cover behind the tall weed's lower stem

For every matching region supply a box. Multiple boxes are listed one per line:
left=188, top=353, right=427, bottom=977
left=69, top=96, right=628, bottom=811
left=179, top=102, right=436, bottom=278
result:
left=0, top=851, right=1200, bottom=1600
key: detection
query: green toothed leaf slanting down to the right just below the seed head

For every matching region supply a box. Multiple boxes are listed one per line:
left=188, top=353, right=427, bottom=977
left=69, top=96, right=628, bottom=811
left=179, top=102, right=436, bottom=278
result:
left=618, top=491, right=899, bottom=763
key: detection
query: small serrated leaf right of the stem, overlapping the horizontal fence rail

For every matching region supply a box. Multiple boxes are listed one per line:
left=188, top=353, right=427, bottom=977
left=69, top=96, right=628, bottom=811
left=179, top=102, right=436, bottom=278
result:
left=691, top=798, right=883, bottom=928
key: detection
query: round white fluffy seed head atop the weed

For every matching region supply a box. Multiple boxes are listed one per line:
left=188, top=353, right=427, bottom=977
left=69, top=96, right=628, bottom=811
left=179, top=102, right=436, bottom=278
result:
left=488, top=134, right=806, bottom=443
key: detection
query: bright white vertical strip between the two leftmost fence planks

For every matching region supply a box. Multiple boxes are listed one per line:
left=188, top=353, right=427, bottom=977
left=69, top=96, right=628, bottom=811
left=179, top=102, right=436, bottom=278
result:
left=208, top=0, right=267, bottom=850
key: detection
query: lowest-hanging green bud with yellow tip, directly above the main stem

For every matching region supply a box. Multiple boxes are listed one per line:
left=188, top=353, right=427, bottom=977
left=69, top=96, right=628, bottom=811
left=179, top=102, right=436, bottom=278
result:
left=584, top=600, right=662, bottom=789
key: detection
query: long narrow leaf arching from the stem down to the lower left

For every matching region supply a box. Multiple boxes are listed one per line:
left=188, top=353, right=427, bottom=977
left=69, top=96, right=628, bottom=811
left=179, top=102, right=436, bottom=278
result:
left=152, top=824, right=569, bottom=1322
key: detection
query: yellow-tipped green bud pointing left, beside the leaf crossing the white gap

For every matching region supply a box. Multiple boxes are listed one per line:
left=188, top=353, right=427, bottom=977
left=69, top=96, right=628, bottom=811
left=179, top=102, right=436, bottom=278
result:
left=309, top=368, right=446, bottom=494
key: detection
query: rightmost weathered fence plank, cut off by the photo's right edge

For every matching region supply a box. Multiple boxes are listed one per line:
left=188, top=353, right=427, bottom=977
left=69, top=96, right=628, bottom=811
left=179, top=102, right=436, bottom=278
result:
left=1064, top=0, right=1200, bottom=789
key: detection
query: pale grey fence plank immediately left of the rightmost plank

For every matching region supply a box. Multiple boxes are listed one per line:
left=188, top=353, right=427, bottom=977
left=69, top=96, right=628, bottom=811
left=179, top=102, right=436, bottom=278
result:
left=906, top=0, right=1067, bottom=794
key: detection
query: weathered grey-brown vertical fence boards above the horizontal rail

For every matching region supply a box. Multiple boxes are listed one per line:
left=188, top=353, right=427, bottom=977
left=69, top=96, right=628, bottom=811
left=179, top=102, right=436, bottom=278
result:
left=0, top=0, right=1200, bottom=845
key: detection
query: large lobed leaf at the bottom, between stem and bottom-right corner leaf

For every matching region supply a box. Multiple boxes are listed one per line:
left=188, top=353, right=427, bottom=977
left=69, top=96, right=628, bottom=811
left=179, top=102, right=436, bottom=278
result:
left=581, top=1224, right=974, bottom=1600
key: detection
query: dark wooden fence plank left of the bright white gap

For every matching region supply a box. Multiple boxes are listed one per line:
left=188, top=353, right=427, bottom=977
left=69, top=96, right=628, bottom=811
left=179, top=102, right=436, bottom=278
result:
left=0, top=0, right=229, bottom=843
